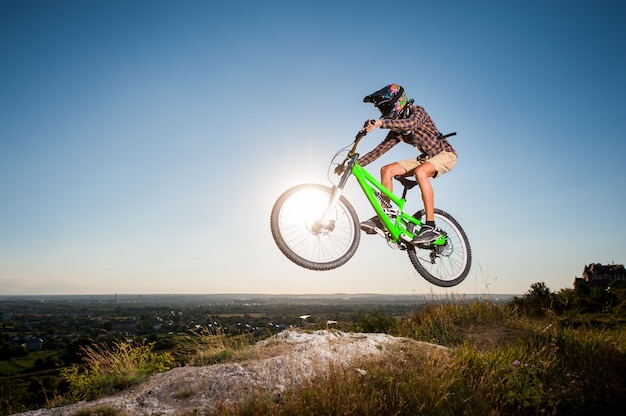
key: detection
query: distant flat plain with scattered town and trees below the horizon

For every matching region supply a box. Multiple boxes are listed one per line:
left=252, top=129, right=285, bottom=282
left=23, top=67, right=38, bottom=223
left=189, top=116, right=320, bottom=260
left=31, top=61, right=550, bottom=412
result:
left=0, top=294, right=511, bottom=359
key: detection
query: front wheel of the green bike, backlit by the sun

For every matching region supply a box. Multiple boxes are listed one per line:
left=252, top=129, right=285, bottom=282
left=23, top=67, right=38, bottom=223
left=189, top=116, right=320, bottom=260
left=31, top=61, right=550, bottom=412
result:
left=270, top=184, right=361, bottom=270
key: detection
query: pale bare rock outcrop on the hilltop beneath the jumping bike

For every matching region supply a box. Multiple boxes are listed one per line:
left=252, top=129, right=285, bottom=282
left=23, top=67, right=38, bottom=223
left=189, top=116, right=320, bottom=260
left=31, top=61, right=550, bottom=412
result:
left=15, top=331, right=443, bottom=416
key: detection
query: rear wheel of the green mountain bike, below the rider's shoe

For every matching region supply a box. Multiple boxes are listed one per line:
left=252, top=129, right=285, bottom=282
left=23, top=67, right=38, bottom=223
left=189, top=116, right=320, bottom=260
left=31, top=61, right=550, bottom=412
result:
left=407, top=209, right=472, bottom=287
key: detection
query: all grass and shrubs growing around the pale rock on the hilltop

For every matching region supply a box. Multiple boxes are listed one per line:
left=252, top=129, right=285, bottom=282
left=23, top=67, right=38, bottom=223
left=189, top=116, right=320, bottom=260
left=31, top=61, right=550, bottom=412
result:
left=4, top=283, right=626, bottom=416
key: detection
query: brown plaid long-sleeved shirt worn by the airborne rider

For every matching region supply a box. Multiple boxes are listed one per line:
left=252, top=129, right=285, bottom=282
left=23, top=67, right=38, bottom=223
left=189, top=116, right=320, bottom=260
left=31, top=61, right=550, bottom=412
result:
left=359, top=105, right=456, bottom=166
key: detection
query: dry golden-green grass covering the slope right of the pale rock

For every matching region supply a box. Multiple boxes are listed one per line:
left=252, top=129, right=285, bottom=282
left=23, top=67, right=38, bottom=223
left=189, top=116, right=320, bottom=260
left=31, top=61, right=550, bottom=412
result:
left=205, top=302, right=626, bottom=415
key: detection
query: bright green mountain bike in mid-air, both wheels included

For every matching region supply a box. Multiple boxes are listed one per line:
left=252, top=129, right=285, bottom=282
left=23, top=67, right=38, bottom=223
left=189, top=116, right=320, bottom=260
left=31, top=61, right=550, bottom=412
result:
left=270, top=125, right=472, bottom=287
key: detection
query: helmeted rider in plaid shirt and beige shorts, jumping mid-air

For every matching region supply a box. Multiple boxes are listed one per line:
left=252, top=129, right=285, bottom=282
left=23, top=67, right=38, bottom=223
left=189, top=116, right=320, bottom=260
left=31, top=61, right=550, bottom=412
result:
left=359, top=84, right=457, bottom=244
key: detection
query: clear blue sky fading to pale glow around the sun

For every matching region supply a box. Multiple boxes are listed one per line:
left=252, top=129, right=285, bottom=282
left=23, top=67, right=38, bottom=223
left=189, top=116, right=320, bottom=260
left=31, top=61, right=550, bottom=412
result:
left=0, top=0, right=626, bottom=294
